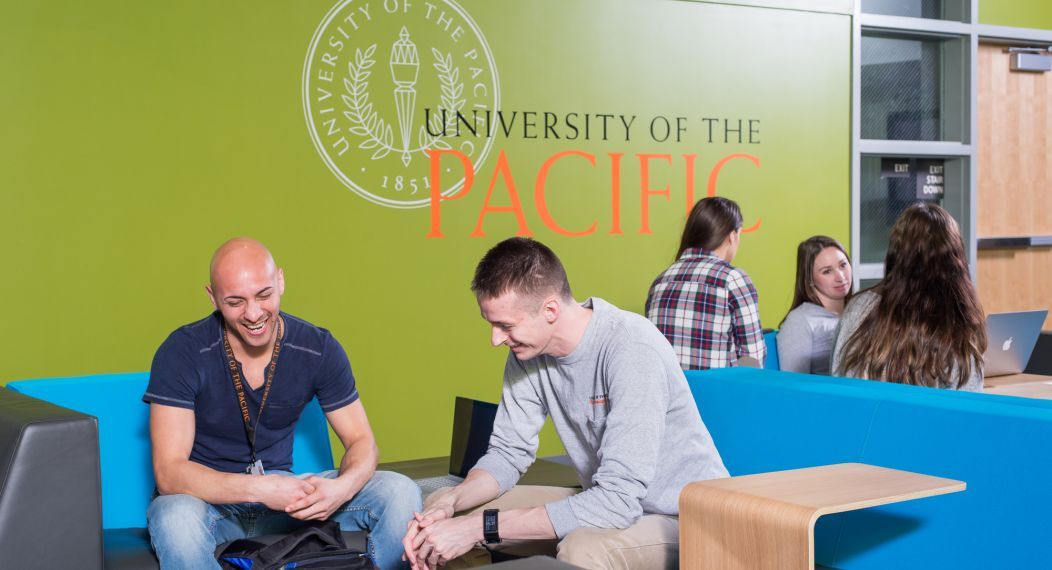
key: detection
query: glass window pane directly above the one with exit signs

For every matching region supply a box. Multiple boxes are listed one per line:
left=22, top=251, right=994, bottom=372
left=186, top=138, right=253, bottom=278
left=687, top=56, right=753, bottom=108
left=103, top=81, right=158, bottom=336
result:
left=862, top=33, right=968, bottom=142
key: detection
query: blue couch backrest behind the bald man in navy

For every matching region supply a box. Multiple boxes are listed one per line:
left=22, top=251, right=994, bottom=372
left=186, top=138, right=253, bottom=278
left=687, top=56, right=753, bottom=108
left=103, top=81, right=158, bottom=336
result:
left=7, top=372, right=332, bottom=529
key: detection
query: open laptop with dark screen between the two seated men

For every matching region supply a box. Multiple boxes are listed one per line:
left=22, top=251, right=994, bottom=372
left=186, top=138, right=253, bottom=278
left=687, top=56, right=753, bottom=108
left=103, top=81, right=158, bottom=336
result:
left=417, top=396, right=497, bottom=496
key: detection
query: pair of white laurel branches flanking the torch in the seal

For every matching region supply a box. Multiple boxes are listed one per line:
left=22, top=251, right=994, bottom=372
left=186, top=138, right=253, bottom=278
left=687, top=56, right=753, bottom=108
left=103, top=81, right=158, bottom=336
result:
left=341, top=44, right=466, bottom=160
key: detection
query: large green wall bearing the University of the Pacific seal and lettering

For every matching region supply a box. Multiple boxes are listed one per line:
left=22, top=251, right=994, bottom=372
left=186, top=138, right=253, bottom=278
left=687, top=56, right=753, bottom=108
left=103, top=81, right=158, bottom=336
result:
left=0, top=0, right=851, bottom=461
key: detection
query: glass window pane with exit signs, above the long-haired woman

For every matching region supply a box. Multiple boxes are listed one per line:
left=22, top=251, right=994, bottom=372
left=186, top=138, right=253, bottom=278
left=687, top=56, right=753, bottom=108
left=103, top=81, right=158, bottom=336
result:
left=857, top=156, right=970, bottom=263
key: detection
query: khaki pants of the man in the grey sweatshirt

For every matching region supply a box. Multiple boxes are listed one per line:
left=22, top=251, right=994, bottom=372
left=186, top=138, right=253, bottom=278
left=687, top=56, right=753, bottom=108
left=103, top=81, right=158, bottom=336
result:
left=425, top=485, right=680, bottom=570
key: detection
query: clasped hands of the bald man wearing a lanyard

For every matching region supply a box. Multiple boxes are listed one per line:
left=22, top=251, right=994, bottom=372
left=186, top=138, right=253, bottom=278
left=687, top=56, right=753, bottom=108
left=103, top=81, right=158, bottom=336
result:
left=254, top=475, right=355, bottom=521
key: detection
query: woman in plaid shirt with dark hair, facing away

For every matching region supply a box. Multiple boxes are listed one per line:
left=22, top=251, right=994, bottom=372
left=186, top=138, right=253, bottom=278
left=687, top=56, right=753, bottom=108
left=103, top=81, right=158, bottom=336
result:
left=647, top=197, right=767, bottom=370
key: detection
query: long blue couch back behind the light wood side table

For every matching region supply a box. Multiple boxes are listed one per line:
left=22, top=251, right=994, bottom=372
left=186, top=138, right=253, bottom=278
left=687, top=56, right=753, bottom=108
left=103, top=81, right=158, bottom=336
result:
left=687, top=368, right=1052, bottom=569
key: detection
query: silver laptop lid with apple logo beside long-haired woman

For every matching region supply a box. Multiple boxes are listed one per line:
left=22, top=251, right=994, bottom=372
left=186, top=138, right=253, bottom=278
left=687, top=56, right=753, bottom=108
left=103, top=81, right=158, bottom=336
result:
left=983, top=309, right=1049, bottom=378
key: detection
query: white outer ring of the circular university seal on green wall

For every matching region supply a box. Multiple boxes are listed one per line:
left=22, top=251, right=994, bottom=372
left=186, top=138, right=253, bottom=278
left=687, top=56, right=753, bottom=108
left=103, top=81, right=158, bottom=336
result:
left=302, top=0, right=501, bottom=208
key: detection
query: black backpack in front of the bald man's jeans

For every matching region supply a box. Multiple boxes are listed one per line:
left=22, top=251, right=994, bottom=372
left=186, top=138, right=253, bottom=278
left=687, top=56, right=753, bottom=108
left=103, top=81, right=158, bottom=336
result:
left=216, top=521, right=377, bottom=570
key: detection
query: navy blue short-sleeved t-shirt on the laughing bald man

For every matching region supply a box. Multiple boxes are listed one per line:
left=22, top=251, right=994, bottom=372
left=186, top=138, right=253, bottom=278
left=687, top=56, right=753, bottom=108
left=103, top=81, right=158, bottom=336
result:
left=142, top=311, right=358, bottom=473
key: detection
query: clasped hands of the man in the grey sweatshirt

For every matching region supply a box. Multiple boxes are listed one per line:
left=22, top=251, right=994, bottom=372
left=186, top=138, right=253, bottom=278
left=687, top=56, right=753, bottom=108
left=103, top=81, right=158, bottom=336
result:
left=402, top=500, right=483, bottom=570
